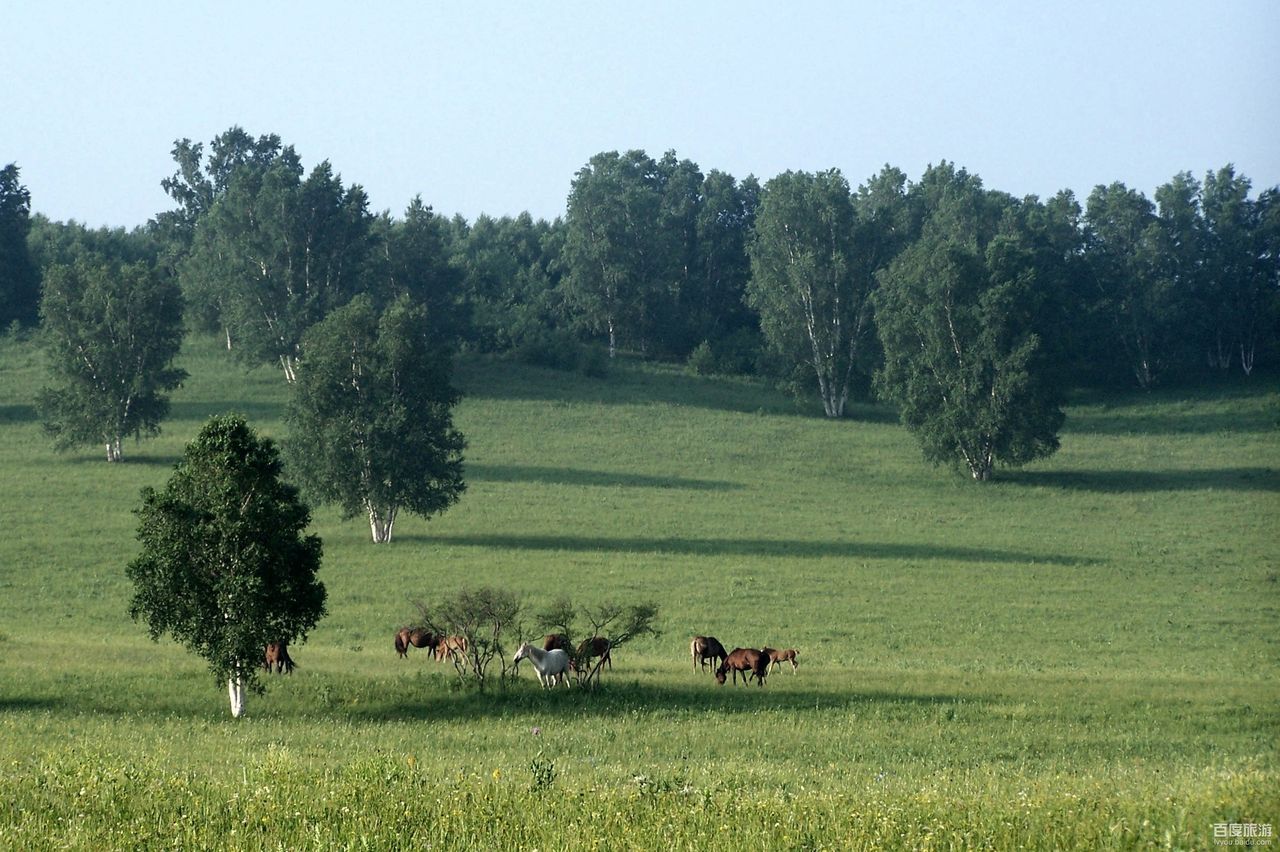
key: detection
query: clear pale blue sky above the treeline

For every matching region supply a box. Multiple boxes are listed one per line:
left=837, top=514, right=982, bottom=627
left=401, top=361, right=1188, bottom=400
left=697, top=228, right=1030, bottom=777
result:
left=0, top=0, right=1280, bottom=228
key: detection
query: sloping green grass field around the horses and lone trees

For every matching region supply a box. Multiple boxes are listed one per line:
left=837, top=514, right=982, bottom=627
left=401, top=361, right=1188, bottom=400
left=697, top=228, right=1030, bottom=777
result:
left=0, top=339, right=1280, bottom=849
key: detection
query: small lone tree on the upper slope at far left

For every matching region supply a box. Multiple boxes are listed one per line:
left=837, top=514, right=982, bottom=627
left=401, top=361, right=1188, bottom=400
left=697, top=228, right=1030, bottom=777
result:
left=37, top=255, right=187, bottom=462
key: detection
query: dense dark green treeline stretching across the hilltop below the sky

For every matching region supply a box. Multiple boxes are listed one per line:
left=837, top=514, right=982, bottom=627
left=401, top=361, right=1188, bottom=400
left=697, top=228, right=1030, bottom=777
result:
left=0, top=128, right=1280, bottom=478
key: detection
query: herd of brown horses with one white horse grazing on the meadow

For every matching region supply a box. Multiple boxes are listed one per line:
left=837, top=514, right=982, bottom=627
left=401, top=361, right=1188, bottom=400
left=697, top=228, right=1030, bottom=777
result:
left=262, top=627, right=800, bottom=688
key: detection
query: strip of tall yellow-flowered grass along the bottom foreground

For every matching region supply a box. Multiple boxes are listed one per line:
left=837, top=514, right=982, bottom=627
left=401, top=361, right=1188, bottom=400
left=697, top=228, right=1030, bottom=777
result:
left=0, top=751, right=1276, bottom=851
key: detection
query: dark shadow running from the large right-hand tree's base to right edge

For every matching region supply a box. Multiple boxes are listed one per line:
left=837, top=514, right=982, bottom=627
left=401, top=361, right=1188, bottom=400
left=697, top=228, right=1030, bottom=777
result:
left=1001, top=467, right=1280, bottom=494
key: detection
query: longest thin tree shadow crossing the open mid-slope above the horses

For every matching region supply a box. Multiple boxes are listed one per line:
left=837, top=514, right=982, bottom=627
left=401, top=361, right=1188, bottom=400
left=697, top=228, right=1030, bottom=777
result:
left=406, top=533, right=1097, bottom=565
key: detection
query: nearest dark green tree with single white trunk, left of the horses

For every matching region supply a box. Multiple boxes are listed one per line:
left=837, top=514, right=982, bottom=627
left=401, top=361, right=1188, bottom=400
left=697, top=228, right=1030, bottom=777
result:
left=127, top=416, right=325, bottom=716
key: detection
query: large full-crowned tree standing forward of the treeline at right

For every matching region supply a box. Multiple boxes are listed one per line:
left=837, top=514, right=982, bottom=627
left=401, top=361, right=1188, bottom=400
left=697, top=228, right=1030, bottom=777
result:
left=876, top=165, right=1064, bottom=481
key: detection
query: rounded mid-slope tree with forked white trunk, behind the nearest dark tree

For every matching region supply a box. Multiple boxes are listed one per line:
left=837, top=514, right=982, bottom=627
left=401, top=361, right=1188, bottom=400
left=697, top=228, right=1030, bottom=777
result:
left=287, top=296, right=466, bottom=542
